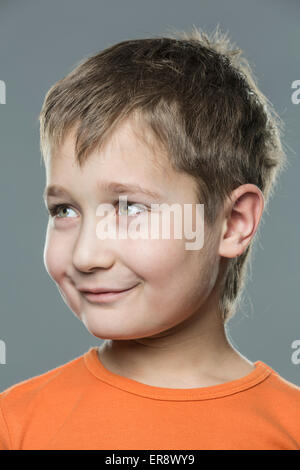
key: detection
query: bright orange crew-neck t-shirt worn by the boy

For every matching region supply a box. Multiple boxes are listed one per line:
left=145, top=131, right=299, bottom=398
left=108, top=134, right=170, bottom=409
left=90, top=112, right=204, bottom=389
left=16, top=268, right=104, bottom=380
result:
left=0, top=347, right=300, bottom=450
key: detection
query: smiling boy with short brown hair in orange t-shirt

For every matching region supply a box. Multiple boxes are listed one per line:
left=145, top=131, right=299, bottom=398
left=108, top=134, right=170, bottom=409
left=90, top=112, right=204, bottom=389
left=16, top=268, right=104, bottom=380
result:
left=0, top=28, right=300, bottom=450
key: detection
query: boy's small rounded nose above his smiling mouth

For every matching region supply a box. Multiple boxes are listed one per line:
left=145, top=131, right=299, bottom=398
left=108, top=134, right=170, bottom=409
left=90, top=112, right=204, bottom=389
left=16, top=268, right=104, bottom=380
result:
left=72, top=219, right=116, bottom=272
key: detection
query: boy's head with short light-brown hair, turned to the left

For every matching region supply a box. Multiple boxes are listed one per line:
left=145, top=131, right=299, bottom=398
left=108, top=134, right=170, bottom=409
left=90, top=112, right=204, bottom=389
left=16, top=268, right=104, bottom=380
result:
left=40, top=25, right=286, bottom=328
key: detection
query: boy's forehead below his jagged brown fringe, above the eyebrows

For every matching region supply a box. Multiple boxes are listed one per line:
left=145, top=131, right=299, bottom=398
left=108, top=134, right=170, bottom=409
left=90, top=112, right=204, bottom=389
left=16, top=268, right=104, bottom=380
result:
left=46, top=119, right=196, bottom=200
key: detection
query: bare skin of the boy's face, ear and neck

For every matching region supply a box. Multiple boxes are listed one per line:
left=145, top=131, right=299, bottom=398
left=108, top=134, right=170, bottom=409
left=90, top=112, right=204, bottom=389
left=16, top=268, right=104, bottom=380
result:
left=44, top=115, right=264, bottom=388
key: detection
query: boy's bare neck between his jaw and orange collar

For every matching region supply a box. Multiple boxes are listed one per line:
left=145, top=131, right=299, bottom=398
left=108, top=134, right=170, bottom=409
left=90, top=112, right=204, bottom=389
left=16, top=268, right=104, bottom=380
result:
left=99, top=304, right=254, bottom=388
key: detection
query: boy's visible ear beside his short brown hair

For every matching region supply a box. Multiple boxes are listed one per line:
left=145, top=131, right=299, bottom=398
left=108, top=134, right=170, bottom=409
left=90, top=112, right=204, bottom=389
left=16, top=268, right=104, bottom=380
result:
left=219, top=184, right=264, bottom=258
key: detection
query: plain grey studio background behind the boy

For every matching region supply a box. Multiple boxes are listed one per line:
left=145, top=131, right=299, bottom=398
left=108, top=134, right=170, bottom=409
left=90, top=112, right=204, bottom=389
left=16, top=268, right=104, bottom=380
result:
left=0, top=0, right=300, bottom=391
